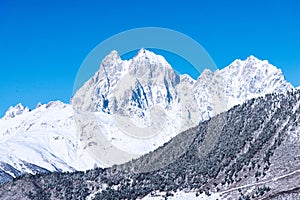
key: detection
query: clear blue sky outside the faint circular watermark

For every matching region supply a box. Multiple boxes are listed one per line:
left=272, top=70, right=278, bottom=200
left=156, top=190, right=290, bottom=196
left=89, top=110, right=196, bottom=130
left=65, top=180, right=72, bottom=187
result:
left=0, top=0, right=300, bottom=116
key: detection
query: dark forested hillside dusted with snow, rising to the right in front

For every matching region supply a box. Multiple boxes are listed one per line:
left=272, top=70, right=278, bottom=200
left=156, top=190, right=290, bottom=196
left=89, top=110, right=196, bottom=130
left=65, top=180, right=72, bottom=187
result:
left=0, top=91, right=300, bottom=199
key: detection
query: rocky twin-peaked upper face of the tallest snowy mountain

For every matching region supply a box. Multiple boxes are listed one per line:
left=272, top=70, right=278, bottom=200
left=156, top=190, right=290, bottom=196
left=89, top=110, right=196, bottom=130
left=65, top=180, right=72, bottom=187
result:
left=72, top=49, right=198, bottom=129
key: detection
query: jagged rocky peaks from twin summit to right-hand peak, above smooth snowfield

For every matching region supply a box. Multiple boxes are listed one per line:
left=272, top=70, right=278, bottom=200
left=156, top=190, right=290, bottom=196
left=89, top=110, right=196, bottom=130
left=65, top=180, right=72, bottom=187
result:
left=72, top=49, right=293, bottom=122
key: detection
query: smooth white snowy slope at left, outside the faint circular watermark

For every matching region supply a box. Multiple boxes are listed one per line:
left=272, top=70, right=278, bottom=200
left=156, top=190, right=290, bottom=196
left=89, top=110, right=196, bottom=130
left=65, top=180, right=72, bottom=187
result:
left=0, top=101, right=95, bottom=184
